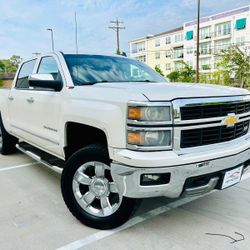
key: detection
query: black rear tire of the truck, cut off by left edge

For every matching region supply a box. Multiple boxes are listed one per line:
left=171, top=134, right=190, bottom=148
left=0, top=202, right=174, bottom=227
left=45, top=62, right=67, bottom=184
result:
left=0, top=114, right=18, bottom=155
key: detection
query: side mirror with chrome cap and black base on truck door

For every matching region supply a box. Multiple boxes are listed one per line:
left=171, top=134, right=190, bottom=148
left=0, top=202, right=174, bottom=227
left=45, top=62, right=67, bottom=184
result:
left=29, top=74, right=63, bottom=91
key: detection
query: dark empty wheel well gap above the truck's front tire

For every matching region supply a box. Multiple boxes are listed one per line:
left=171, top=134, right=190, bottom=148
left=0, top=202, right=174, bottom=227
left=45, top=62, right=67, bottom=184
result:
left=64, top=122, right=107, bottom=159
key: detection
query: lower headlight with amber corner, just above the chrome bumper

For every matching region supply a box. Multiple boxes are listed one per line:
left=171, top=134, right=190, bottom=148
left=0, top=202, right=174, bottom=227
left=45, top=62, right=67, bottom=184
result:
left=127, top=128, right=172, bottom=150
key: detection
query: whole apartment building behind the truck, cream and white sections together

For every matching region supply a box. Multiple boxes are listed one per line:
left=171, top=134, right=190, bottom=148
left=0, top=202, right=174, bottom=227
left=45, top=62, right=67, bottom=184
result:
left=129, top=6, right=250, bottom=75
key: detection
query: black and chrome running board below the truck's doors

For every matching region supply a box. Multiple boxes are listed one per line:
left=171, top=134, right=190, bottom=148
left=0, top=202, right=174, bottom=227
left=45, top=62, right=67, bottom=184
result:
left=16, top=142, right=64, bottom=174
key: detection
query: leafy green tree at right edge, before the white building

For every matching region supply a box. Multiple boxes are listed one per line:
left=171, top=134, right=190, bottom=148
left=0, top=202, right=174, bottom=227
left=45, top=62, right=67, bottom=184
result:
left=217, top=45, right=250, bottom=88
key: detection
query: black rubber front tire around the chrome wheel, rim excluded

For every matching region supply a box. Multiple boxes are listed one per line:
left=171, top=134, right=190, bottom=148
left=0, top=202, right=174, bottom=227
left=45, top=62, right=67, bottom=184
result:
left=61, top=144, right=135, bottom=229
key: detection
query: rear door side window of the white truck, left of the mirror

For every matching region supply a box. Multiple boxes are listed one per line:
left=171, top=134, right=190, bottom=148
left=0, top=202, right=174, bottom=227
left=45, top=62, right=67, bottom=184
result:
left=16, top=59, right=36, bottom=89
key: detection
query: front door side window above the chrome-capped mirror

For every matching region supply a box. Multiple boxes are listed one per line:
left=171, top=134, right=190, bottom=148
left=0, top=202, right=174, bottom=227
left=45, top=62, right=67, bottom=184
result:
left=37, top=56, right=61, bottom=80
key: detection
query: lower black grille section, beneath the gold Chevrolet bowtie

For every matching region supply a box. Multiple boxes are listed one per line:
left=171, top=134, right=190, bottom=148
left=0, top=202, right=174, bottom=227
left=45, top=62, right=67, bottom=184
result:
left=181, top=121, right=249, bottom=148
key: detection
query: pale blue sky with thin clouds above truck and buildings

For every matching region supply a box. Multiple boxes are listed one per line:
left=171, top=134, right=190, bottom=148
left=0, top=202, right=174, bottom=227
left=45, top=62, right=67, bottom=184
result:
left=0, top=0, right=249, bottom=58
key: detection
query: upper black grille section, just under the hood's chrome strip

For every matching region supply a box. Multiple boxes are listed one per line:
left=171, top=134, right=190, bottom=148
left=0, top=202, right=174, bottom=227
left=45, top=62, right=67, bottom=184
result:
left=180, top=102, right=250, bottom=120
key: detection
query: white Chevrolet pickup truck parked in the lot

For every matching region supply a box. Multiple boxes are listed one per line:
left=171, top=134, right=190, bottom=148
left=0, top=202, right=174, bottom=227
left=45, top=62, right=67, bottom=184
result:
left=0, top=52, right=250, bottom=229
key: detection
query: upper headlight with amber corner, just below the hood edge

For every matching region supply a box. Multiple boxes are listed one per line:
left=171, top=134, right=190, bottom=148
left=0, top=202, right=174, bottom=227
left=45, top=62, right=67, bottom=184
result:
left=128, top=106, right=171, bottom=123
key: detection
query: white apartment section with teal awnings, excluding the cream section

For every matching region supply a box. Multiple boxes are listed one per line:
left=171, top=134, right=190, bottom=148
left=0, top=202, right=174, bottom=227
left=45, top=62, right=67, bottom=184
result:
left=183, top=6, right=250, bottom=73
